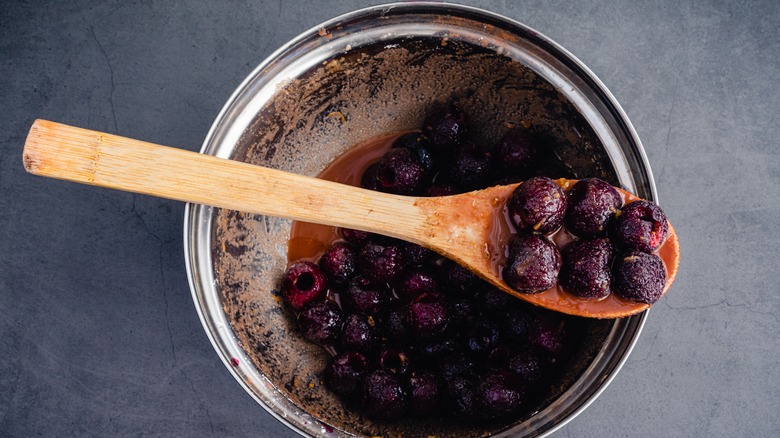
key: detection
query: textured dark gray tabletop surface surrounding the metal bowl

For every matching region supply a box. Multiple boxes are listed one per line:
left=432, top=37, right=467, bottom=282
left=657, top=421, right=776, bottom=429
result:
left=0, top=0, right=780, bottom=437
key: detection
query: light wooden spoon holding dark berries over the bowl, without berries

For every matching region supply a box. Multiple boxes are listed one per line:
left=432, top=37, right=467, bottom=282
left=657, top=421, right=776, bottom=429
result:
left=23, top=120, right=680, bottom=318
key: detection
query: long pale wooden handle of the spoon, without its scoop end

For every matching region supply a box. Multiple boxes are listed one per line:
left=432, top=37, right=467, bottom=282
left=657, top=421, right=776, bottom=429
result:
left=23, top=120, right=425, bottom=241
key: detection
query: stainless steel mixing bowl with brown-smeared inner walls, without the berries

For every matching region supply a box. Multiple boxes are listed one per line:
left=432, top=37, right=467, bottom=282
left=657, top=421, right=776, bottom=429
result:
left=184, top=2, right=657, bottom=437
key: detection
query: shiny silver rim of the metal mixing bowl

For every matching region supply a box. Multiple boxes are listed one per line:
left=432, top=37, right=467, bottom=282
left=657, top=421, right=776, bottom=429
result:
left=183, top=1, right=658, bottom=436
